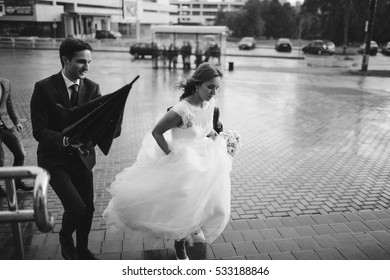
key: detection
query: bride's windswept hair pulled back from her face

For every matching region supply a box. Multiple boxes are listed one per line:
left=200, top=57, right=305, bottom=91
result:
left=178, top=62, right=222, bottom=100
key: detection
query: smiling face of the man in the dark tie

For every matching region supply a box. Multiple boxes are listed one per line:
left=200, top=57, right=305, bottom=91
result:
left=62, top=50, right=92, bottom=81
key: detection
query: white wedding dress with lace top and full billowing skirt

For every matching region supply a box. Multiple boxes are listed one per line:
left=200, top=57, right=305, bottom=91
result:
left=103, top=99, right=232, bottom=243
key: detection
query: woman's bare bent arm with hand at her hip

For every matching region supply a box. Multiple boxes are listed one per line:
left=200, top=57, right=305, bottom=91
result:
left=152, top=110, right=182, bottom=155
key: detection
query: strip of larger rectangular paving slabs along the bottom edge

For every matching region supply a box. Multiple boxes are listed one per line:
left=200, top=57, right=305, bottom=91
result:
left=0, top=211, right=390, bottom=260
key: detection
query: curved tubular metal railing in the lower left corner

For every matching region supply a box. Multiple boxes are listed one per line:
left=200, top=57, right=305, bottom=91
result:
left=0, top=166, right=54, bottom=259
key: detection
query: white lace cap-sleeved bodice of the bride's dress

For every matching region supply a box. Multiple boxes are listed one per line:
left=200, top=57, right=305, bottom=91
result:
left=171, top=98, right=215, bottom=139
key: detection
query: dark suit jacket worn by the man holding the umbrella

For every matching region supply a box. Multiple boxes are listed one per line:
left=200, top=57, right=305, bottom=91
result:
left=30, top=72, right=101, bottom=171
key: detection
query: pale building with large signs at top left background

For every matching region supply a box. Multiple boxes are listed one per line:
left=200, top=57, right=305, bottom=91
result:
left=0, top=0, right=177, bottom=37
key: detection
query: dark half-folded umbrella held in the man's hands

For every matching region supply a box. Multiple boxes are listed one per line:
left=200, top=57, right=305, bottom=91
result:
left=61, top=76, right=139, bottom=155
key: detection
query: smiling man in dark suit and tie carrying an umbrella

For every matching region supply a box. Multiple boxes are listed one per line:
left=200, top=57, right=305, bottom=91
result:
left=30, top=38, right=101, bottom=259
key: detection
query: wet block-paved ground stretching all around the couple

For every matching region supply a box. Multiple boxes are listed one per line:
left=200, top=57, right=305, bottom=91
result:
left=0, top=49, right=390, bottom=259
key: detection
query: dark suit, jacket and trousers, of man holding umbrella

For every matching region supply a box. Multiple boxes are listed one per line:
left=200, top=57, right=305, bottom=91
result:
left=30, top=72, right=101, bottom=254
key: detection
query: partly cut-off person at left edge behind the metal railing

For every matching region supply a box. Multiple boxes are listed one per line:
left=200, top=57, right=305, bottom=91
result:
left=0, top=77, right=33, bottom=196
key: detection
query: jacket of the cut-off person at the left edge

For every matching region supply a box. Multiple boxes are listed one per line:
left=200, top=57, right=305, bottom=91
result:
left=0, top=78, right=19, bottom=129
